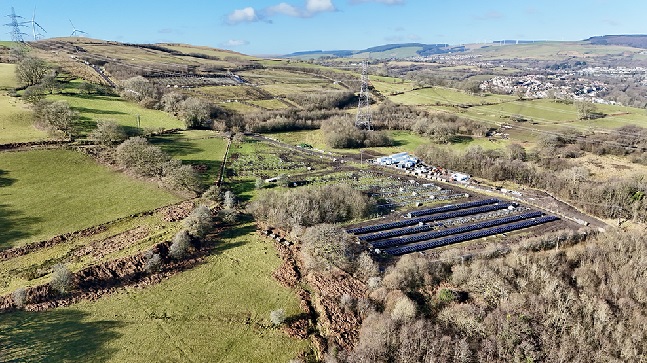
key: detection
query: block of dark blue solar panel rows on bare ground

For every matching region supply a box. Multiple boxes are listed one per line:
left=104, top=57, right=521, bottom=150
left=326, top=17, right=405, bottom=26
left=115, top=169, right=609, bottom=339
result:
left=346, top=198, right=559, bottom=256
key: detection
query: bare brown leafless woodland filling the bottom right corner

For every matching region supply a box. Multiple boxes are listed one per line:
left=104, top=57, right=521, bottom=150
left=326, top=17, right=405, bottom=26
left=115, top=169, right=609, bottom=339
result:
left=330, top=231, right=647, bottom=363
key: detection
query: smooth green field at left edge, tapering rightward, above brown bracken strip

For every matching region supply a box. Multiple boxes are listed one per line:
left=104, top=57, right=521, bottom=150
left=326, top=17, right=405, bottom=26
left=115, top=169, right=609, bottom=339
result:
left=0, top=150, right=179, bottom=248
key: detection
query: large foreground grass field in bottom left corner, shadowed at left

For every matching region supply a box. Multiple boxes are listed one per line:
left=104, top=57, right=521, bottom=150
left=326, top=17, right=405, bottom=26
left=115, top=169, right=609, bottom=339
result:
left=0, top=225, right=309, bottom=362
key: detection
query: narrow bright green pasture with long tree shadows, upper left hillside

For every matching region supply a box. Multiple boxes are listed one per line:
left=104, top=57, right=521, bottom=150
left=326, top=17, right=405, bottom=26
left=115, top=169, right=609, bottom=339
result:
left=48, top=94, right=185, bottom=134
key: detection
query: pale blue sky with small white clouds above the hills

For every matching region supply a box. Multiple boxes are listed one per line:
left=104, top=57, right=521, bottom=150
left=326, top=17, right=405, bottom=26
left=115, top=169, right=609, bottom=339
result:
left=0, top=0, right=647, bottom=55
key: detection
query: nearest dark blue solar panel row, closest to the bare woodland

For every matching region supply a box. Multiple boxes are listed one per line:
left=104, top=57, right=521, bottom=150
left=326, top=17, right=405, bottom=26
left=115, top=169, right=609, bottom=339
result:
left=386, top=216, right=559, bottom=256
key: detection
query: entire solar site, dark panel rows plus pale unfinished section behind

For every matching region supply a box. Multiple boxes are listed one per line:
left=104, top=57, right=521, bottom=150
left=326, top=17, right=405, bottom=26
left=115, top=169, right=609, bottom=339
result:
left=229, top=140, right=560, bottom=256
